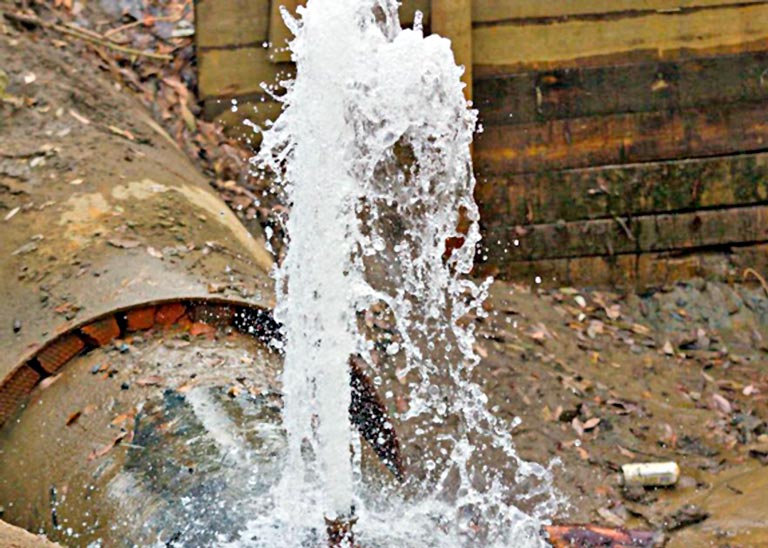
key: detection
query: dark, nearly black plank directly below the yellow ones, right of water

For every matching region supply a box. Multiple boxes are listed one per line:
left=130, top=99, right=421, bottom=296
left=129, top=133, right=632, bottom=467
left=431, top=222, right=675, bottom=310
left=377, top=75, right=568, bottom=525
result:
left=475, top=51, right=768, bottom=125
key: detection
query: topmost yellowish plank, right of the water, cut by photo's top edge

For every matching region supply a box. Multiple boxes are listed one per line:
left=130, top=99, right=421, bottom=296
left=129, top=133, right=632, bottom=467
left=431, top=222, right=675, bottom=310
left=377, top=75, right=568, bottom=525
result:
left=472, top=0, right=765, bottom=23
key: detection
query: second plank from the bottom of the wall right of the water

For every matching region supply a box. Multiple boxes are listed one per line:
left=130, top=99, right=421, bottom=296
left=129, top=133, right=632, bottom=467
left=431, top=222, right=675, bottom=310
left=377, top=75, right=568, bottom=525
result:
left=485, top=205, right=768, bottom=261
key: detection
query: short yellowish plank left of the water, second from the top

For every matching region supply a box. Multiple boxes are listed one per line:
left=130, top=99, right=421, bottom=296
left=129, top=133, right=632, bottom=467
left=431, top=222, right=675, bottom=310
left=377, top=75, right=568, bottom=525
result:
left=198, top=45, right=286, bottom=99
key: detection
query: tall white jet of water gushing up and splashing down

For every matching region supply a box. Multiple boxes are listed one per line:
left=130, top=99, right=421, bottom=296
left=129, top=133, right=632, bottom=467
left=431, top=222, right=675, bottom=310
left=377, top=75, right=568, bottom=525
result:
left=249, top=0, right=558, bottom=546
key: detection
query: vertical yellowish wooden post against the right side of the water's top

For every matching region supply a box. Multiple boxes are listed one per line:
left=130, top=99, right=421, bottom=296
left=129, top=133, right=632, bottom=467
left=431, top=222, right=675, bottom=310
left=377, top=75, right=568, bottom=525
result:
left=430, top=0, right=472, bottom=100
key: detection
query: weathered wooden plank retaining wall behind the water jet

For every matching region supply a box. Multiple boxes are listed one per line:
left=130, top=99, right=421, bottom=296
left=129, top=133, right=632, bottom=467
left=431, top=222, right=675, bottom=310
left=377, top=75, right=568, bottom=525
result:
left=197, top=0, right=768, bottom=286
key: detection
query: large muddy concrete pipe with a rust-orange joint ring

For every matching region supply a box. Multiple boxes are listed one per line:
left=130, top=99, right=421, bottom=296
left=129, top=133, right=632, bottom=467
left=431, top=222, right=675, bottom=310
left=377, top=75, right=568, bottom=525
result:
left=0, top=36, right=401, bottom=546
